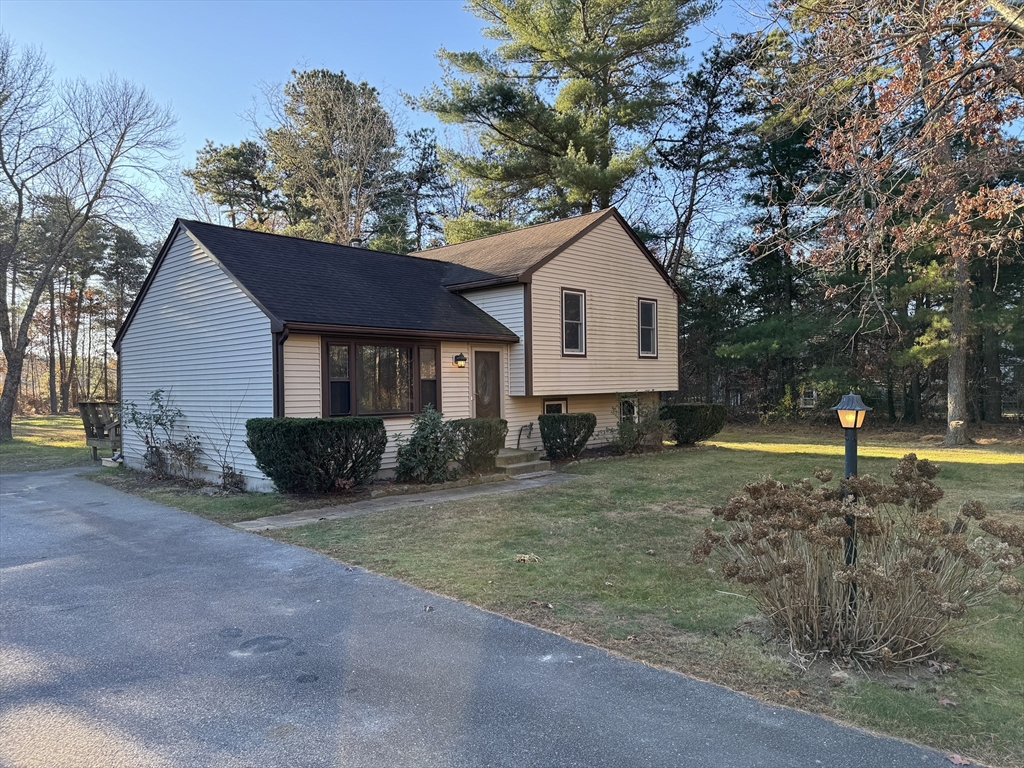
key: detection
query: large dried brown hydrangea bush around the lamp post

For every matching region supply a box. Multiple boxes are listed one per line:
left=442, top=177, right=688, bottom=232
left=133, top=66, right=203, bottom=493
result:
left=692, top=454, right=1024, bottom=663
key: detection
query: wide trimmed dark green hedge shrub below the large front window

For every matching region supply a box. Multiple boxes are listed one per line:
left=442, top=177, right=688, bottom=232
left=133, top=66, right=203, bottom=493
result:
left=246, top=417, right=387, bottom=494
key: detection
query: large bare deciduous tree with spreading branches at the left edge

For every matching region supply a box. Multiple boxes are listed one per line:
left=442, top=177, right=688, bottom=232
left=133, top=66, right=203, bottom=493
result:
left=0, top=36, right=176, bottom=440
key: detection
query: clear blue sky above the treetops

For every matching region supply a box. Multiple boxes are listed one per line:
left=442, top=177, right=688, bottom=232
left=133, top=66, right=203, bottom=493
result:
left=0, top=0, right=742, bottom=171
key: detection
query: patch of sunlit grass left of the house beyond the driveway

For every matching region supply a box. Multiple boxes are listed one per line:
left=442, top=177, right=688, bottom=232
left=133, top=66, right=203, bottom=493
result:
left=0, top=415, right=93, bottom=472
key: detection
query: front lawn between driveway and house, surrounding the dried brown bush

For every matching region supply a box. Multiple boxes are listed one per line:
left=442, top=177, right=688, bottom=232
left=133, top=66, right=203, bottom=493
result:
left=268, top=430, right=1024, bottom=766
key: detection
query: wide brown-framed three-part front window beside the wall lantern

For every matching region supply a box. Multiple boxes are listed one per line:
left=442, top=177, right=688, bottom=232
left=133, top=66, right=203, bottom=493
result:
left=326, top=342, right=439, bottom=416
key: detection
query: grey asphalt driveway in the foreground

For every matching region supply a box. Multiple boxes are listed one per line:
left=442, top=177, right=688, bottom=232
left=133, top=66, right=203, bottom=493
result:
left=0, top=470, right=949, bottom=768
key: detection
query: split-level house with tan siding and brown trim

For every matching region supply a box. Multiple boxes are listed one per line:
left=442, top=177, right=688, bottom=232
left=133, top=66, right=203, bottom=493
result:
left=114, top=209, right=679, bottom=489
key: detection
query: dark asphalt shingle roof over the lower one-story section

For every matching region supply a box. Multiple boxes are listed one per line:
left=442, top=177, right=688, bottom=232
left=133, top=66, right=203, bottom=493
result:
left=179, top=220, right=516, bottom=339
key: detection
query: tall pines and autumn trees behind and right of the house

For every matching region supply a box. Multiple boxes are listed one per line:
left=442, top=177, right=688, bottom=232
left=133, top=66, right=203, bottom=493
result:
left=0, top=0, right=1024, bottom=444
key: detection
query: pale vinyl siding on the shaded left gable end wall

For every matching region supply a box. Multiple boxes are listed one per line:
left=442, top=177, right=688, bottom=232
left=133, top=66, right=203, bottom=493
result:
left=120, top=229, right=273, bottom=489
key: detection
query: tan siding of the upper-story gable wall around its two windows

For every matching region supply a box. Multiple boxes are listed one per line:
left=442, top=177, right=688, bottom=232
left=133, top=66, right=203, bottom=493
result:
left=530, top=219, right=679, bottom=395
